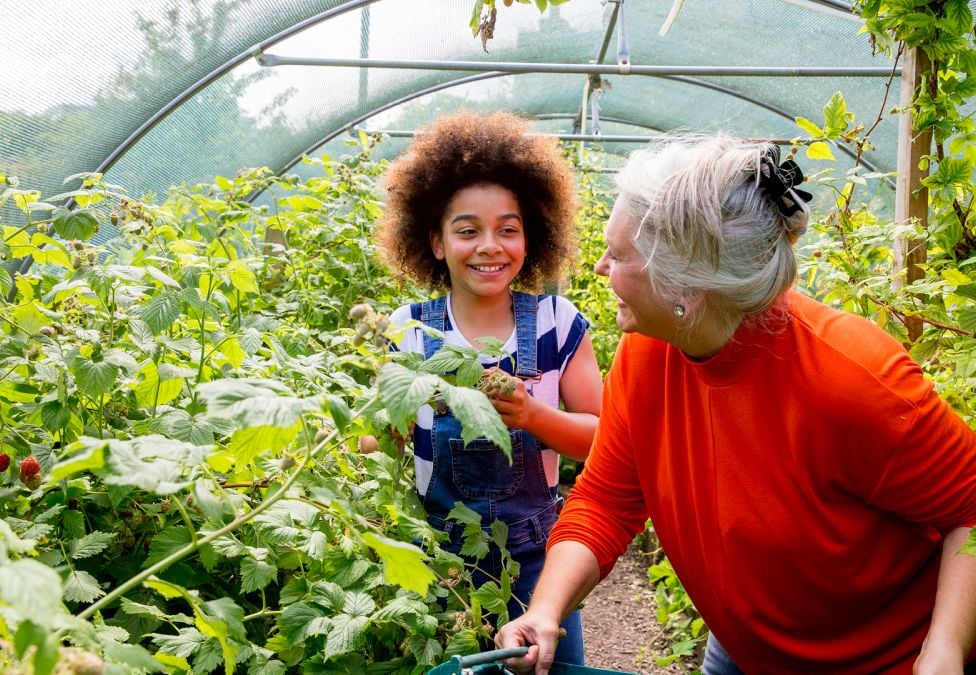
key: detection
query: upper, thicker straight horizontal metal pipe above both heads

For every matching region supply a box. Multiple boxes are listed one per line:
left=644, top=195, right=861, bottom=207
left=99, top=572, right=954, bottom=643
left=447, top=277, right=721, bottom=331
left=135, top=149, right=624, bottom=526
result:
left=255, top=52, right=900, bottom=77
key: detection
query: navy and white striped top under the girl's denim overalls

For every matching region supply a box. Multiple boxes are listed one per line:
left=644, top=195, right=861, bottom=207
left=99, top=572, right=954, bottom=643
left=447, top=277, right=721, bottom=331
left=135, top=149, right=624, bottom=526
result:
left=390, top=294, right=590, bottom=495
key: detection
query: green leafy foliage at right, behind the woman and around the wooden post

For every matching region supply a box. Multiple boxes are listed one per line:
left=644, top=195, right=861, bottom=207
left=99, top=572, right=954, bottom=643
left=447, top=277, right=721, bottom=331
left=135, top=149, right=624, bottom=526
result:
left=797, top=0, right=976, bottom=425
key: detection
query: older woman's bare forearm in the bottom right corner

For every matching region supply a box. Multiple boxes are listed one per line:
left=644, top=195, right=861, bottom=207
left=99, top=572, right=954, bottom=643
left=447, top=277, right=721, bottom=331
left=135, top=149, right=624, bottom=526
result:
left=915, top=527, right=976, bottom=675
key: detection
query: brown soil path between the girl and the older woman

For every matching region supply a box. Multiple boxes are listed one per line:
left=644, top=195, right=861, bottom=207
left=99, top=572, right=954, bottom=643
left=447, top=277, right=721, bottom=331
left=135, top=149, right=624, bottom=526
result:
left=583, top=546, right=690, bottom=675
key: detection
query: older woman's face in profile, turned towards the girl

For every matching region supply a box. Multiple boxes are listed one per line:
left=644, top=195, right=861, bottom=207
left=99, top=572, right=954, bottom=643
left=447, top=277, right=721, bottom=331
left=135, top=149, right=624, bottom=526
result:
left=596, top=198, right=677, bottom=340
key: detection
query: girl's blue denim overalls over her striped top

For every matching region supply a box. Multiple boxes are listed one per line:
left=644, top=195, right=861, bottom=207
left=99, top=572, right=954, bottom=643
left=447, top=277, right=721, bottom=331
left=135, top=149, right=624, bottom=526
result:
left=420, top=292, right=583, bottom=664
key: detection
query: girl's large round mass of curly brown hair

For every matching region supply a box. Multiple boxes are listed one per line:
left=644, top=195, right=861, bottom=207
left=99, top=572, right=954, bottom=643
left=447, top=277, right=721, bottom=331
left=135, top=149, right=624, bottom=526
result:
left=376, top=112, right=578, bottom=290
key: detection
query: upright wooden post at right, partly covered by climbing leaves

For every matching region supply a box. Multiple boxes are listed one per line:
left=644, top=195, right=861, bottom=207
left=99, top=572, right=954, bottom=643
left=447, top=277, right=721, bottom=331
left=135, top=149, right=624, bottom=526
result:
left=894, top=48, right=932, bottom=344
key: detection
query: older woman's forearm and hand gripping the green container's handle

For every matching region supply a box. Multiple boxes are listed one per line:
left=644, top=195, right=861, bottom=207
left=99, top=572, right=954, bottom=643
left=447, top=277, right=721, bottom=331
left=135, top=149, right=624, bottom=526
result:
left=495, top=541, right=600, bottom=674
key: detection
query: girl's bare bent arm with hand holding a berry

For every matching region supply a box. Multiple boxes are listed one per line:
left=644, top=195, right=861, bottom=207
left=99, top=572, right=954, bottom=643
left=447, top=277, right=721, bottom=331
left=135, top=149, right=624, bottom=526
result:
left=491, top=335, right=603, bottom=460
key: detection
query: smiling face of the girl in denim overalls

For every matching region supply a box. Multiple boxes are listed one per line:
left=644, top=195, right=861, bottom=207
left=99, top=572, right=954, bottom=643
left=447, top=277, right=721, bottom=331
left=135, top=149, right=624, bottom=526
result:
left=430, top=184, right=525, bottom=297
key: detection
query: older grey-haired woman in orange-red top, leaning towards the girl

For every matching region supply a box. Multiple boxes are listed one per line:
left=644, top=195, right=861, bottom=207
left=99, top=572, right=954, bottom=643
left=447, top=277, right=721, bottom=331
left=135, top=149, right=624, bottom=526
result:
left=496, top=137, right=976, bottom=675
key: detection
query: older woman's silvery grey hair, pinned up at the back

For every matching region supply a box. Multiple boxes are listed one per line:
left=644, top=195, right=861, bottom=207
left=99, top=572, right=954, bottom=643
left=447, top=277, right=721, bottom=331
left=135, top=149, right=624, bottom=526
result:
left=617, top=135, right=810, bottom=336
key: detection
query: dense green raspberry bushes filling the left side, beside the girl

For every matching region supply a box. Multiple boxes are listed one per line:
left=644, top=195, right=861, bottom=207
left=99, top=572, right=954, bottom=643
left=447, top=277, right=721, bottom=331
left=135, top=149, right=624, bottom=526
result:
left=0, top=136, right=514, bottom=673
